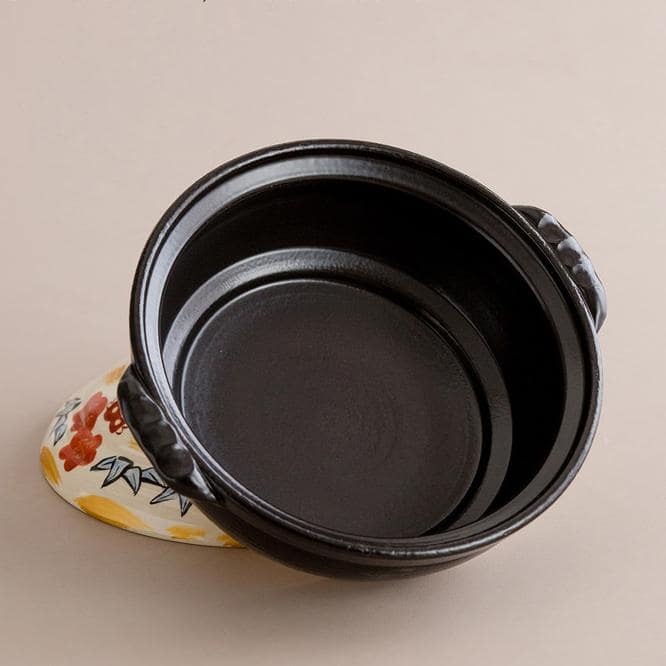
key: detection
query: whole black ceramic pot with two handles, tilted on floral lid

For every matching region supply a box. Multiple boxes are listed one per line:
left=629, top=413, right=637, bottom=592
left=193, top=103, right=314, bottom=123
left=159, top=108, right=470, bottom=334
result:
left=119, top=141, right=606, bottom=578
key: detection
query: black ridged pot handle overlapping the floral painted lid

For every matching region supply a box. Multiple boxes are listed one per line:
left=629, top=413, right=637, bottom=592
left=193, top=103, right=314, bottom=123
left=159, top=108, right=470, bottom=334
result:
left=118, top=365, right=216, bottom=501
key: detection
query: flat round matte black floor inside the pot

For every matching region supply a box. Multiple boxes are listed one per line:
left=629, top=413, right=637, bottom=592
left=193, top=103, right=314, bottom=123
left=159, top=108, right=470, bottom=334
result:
left=179, top=279, right=483, bottom=537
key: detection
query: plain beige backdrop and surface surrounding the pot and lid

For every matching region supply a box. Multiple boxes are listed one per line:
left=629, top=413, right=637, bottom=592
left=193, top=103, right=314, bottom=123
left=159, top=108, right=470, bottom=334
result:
left=0, top=0, right=666, bottom=666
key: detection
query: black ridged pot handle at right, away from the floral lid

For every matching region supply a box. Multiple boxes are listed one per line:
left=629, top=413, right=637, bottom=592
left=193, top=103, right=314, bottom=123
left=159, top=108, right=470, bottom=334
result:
left=514, top=206, right=608, bottom=331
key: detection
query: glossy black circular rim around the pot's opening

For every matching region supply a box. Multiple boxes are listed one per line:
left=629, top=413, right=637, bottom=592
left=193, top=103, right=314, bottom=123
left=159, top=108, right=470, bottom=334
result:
left=130, top=139, right=601, bottom=563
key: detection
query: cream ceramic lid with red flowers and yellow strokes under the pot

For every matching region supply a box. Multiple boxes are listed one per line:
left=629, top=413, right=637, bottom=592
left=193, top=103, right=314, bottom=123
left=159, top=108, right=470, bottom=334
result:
left=39, top=364, right=242, bottom=548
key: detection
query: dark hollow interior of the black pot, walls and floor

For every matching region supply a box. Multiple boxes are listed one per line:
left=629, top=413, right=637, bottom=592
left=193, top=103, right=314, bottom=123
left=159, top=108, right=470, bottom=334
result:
left=159, top=178, right=565, bottom=537
